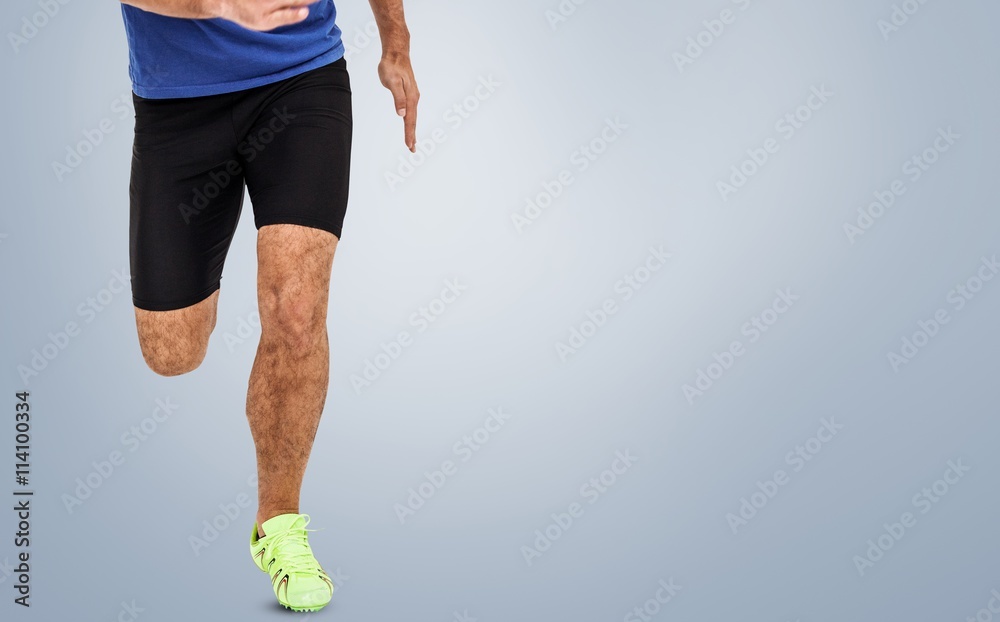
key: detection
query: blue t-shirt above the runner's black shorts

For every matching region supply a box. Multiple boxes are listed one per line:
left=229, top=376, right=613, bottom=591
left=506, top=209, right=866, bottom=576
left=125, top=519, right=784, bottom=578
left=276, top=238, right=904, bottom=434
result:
left=122, top=0, right=344, bottom=99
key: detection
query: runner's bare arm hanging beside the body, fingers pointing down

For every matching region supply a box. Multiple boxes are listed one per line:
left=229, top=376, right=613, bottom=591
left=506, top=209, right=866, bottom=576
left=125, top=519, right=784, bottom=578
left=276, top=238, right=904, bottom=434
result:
left=368, top=0, right=420, bottom=152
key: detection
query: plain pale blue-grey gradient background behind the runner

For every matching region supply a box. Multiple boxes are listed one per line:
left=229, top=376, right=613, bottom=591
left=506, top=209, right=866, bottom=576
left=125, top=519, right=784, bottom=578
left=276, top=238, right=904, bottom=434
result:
left=0, top=0, right=1000, bottom=622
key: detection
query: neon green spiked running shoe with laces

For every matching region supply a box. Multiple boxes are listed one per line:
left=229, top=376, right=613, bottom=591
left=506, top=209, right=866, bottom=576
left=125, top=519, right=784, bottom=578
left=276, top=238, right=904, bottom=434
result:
left=250, top=514, right=333, bottom=611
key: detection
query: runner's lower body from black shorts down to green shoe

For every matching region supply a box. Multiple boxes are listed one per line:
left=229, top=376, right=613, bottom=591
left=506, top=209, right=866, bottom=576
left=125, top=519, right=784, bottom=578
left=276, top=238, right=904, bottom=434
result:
left=130, top=59, right=352, bottom=610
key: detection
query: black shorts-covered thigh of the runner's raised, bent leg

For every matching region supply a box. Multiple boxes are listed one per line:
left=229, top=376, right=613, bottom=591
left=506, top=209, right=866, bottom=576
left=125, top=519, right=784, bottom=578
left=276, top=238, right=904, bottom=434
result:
left=129, top=91, right=244, bottom=311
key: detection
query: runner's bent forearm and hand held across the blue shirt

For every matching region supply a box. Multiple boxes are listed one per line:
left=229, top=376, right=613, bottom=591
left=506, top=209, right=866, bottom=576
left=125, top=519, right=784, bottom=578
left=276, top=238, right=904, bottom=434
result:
left=121, top=0, right=316, bottom=31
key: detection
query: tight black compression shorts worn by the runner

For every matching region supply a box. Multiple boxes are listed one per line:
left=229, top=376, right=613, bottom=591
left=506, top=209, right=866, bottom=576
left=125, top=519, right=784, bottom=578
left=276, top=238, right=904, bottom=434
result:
left=129, top=58, right=353, bottom=311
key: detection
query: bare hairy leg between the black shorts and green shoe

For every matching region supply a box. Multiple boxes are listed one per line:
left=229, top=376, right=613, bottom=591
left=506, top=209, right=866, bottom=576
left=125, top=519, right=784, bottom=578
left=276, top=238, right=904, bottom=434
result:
left=247, top=224, right=338, bottom=535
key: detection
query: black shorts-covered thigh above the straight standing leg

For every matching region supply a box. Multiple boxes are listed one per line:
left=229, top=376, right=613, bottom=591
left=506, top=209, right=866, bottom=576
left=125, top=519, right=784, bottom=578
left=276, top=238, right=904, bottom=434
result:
left=238, top=59, right=353, bottom=239
